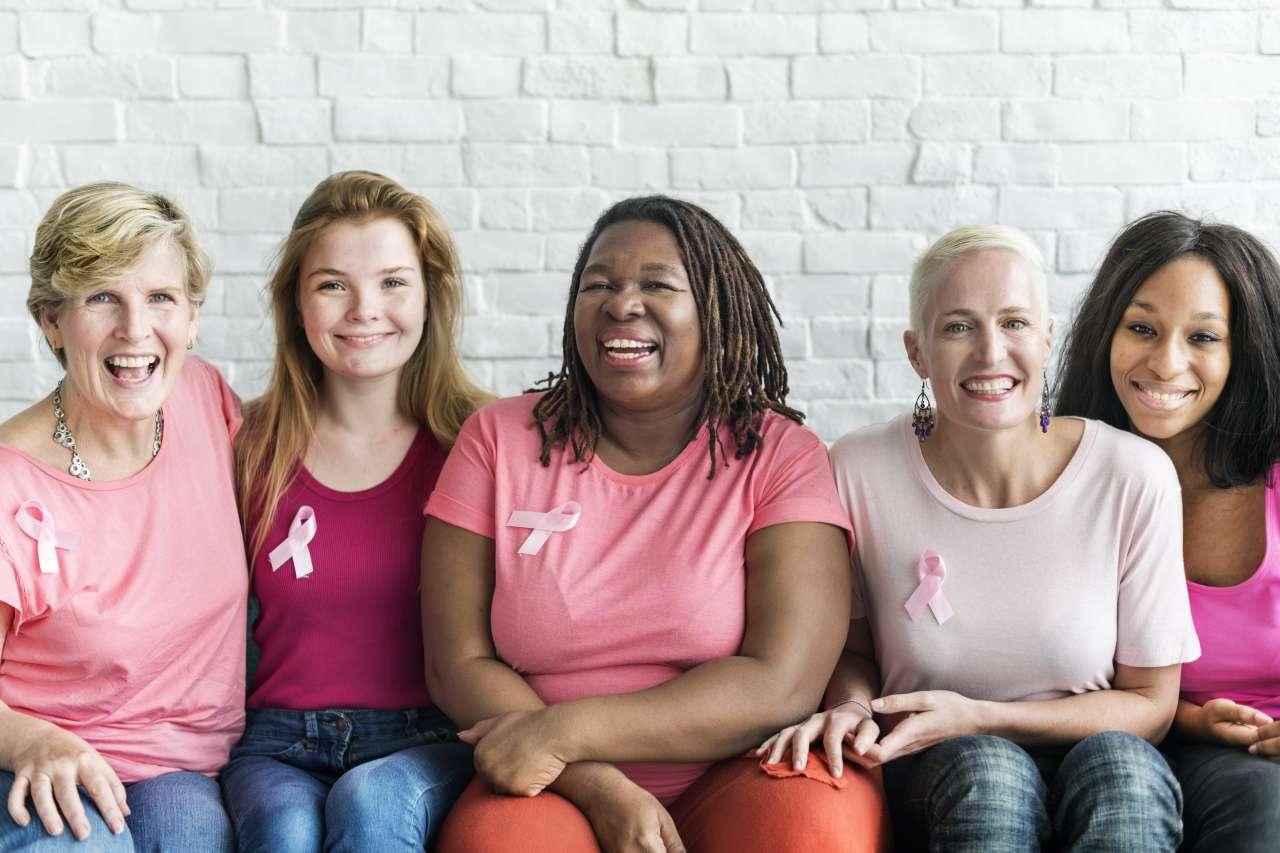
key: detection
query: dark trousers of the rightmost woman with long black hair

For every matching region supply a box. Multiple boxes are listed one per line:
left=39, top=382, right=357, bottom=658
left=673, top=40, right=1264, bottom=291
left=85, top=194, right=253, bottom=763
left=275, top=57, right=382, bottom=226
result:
left=1161, top=738, right=1280, bottom=853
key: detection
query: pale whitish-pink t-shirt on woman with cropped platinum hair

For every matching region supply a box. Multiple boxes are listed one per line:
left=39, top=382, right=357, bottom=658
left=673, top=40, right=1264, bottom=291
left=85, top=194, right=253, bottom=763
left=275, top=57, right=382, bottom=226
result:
left=831, top=415, right=1199, bottom=702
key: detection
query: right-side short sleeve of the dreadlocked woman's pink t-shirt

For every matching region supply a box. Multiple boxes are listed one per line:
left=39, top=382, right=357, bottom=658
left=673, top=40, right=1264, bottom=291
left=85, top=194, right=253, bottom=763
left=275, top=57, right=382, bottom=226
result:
left=746, top=415, right=850, bottom=535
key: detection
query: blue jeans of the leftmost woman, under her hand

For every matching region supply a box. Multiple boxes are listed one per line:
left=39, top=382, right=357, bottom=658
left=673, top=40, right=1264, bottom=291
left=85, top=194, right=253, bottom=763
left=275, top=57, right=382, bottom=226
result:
left=0, top=771, right=236, bottom=853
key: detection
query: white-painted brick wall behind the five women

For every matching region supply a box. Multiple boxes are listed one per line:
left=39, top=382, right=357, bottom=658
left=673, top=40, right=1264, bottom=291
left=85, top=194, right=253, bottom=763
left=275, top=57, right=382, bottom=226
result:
left=0, top=0, right=1280, bottom=438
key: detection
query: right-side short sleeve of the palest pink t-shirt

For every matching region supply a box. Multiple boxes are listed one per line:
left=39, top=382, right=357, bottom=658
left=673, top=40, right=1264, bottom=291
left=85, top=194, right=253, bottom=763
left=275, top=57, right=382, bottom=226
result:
left=1115, top=455, right=1201, bottom=666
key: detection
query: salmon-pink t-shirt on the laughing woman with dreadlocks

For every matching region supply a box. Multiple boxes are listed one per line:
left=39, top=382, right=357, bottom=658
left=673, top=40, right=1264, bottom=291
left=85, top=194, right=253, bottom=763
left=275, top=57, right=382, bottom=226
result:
left=426, top=394, right=849, bottom=803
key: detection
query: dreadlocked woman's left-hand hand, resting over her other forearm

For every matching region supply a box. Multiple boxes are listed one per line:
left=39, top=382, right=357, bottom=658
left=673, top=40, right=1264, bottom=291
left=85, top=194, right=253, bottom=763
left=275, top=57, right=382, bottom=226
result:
left=458, top=708, right=568, bottom=797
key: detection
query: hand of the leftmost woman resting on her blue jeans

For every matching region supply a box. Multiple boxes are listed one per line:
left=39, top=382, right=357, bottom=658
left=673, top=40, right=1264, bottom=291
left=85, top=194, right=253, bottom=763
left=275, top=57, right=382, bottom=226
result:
left=9, top=724, right=129, bottom=840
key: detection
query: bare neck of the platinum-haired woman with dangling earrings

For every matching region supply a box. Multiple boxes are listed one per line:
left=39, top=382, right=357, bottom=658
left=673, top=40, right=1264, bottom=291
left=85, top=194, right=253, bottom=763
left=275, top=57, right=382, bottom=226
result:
left=920, top=412, right=1053, bottom=507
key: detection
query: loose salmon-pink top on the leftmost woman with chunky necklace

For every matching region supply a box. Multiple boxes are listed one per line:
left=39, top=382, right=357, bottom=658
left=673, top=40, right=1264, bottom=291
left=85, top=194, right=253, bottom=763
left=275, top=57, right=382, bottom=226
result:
left=0, top=357, right=248, bottom=783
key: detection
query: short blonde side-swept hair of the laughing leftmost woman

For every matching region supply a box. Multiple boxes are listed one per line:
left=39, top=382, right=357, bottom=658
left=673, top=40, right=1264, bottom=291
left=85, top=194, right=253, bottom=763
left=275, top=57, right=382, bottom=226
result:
left=27, top=182, right=212, bottom=368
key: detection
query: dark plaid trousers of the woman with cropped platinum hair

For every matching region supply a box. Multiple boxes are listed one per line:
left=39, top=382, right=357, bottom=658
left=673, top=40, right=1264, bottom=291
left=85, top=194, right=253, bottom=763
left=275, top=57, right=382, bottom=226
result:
left=884, top=731, right=1183, bottom=853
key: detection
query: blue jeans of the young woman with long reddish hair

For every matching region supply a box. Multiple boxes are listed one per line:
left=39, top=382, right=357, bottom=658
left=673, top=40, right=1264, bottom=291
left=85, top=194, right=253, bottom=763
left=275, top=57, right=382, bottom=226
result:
left=223, top=708, right=472, bottom=853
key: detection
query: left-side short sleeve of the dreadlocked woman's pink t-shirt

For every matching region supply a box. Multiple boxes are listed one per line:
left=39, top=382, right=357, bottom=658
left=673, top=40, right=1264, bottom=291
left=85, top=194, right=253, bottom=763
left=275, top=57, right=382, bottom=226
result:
left=422, top=409, right=498, bottom=539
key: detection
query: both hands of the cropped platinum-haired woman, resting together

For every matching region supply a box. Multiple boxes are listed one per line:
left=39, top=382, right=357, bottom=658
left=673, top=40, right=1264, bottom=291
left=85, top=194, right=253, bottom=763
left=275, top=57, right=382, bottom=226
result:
left=755, top=690, right=982, bottom=777
